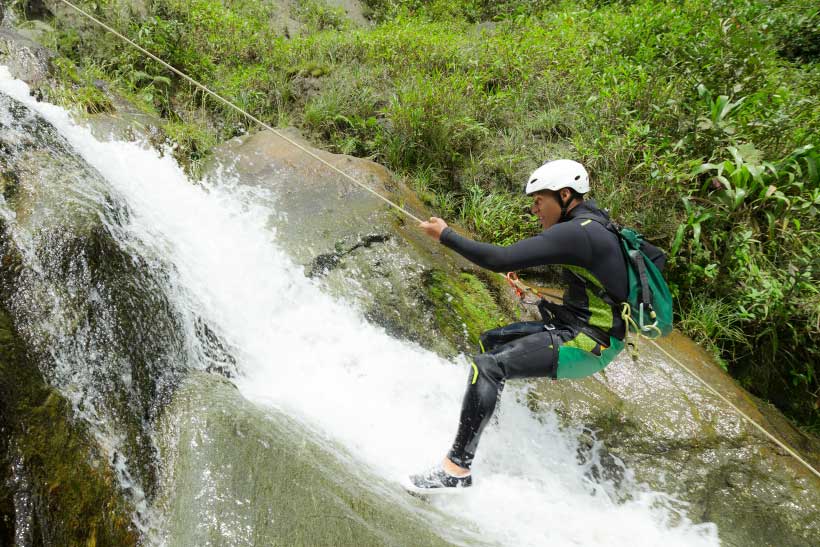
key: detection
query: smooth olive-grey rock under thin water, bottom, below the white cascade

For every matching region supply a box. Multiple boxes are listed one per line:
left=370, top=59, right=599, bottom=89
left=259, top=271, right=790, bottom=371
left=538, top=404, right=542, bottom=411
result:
left=159, top=373, right=468, bottom=546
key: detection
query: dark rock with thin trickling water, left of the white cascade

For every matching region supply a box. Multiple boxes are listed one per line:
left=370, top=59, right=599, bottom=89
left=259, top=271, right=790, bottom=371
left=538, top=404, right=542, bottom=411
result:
left=0, top=92, right=189, bottom=419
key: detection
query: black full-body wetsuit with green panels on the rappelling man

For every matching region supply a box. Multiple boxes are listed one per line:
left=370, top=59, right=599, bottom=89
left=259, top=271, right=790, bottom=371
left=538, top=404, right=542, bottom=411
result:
left=440, top=200, right=628, bottom=468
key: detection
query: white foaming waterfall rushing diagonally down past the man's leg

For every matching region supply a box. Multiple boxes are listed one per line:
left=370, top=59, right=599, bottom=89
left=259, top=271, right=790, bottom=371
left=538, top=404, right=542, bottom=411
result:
left=0, top=67, right=718, bottom=547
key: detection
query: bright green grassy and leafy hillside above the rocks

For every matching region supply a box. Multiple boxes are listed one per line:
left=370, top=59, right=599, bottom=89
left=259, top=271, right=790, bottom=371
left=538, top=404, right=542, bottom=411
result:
left=17, top=0, right=820, bottom=431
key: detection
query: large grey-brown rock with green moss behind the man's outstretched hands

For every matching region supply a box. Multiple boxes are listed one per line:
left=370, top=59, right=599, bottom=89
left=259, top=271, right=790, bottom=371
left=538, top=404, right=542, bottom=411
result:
left=209, top=128, right=519, bottom=356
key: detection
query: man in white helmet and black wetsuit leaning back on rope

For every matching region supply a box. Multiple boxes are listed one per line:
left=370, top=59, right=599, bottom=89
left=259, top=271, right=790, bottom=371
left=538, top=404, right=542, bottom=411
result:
left=410, top=159, right=663, bottom=493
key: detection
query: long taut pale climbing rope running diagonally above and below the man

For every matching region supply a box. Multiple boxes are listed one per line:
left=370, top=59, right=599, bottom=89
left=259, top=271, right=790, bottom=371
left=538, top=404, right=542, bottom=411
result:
left=60, top=0, right=820, bottom=478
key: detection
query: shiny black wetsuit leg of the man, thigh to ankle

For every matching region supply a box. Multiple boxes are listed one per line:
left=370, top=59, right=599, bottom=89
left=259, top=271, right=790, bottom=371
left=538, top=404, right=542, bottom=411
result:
left=447, top=323, right=558, bottom=469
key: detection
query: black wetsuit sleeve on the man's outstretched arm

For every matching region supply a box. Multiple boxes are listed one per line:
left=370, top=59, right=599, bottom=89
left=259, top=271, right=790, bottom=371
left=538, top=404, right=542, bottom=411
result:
left=439, top=222, right=592, bottom=272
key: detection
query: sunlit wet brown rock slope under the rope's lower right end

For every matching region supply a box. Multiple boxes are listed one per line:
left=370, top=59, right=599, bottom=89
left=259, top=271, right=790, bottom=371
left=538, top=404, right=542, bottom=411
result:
left=531, top=333, right=820, bottom=547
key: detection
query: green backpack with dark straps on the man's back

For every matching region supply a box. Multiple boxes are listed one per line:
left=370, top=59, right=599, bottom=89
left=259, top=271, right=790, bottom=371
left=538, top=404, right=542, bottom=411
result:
left=575, top=214, right=672, bottom=338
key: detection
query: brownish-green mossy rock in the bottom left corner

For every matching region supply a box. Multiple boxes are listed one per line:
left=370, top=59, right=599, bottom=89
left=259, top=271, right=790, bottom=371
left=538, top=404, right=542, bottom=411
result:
left=0, top=308, right=138, bottom=545
